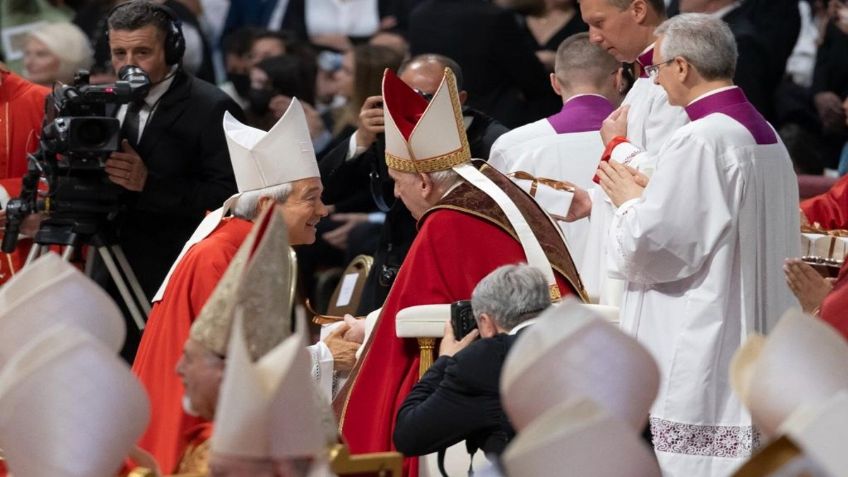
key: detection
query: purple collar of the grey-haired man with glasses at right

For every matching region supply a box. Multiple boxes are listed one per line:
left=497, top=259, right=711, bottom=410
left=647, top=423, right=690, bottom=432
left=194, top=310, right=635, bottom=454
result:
left=686, top=87, right=777, bottom=146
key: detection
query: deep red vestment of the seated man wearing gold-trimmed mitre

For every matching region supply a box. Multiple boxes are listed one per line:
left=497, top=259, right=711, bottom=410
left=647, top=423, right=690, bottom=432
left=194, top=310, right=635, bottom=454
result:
left=340, top=209, right=573, bottom=476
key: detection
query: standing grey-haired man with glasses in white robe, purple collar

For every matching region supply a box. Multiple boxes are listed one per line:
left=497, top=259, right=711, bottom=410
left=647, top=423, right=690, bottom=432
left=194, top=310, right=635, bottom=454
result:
left=598, top=14, right=800, bottom=476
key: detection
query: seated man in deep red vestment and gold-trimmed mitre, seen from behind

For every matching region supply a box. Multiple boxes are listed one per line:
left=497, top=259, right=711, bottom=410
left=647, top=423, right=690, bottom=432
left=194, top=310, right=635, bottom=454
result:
left=336, top=69, right=585, bottom=476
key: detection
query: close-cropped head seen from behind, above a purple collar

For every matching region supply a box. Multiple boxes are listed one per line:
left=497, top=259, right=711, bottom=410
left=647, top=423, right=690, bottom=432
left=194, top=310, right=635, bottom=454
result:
left=554, top=33, right=619, bottom=92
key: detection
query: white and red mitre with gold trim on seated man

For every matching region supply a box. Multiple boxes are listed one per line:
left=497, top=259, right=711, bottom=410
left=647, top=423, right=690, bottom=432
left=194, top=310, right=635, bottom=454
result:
left=383, top=68, right=471, bottom=173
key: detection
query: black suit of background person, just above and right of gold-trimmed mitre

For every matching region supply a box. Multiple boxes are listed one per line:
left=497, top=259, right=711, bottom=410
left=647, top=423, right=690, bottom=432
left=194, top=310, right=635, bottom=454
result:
left=409, top=0, right=562, bottom=128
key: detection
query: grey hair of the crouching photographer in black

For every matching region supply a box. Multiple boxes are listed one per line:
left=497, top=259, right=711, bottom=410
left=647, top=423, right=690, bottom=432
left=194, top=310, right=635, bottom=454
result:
left=471, top=263, right=551, bottom=330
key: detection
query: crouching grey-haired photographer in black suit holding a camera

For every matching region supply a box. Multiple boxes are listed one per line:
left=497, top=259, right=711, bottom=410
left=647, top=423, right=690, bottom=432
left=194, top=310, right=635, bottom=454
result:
left=394, top=264, right=551, bottom=456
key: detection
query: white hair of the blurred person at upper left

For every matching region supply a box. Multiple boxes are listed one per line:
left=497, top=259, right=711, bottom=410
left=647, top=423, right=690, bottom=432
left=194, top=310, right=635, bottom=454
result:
left=27, top=22, right=94, bottom=83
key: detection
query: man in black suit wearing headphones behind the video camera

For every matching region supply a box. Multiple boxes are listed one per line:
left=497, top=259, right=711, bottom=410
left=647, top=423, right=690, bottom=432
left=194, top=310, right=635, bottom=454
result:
left=102, top=0, right=243, bottom=361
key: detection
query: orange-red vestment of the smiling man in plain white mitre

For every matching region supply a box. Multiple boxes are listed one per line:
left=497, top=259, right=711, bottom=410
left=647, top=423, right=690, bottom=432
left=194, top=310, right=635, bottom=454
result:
left=132, top=218, right=253, bottom=473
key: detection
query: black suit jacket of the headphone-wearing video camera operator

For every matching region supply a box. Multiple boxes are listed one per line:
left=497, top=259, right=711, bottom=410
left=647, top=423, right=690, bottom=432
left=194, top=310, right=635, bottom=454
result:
left=109, top=70, right=243, bottom=298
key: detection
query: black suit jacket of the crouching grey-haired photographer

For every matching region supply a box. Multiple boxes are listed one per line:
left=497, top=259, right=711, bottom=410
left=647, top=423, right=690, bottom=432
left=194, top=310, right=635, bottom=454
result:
left=394, top=334, right=518, bottom=456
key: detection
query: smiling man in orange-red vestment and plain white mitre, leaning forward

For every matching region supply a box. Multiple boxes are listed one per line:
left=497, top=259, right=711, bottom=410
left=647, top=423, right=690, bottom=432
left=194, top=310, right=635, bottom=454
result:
left=133, top=99, right=327, bottom=472
